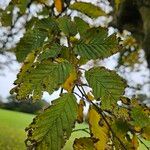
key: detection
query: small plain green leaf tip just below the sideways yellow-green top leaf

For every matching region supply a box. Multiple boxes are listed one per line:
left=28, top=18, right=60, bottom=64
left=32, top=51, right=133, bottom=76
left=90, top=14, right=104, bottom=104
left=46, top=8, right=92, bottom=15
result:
left=74, top=17, right=90, bottom=35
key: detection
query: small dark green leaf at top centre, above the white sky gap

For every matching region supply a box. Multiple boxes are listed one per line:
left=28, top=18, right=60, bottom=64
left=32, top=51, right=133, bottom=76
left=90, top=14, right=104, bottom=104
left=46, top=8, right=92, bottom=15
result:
left=58, top=16, right=77, bottom=36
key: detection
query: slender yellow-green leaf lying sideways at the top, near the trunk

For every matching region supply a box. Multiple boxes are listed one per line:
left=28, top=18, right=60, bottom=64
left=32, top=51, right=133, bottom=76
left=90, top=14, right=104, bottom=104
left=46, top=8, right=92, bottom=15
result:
left=69, top=2, right=106, bottom=18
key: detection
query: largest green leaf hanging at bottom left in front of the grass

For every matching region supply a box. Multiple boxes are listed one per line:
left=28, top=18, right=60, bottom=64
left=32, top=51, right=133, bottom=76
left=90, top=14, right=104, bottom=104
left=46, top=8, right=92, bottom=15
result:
left=27, top=94, right=77, bottom=150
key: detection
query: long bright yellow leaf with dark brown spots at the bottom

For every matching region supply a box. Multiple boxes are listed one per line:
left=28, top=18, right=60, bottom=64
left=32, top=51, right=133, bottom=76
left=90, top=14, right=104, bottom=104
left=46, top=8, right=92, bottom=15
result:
left=88, top=108, right=109, bottom=150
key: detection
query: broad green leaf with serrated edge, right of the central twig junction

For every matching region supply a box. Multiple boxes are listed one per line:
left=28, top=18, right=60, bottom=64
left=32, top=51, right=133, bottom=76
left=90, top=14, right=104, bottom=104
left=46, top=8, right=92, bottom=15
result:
left=85, top=67, right=126, bottom=109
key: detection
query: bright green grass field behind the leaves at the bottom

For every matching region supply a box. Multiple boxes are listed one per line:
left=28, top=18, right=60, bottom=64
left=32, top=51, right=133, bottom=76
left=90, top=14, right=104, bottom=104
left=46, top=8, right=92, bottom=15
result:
left=0, top=109, right=150, bottom=150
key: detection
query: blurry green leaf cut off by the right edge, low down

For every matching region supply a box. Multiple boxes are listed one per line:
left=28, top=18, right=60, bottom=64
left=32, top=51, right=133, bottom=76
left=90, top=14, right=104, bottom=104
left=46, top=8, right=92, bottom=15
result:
left=130, top=107, right=150, bottom=128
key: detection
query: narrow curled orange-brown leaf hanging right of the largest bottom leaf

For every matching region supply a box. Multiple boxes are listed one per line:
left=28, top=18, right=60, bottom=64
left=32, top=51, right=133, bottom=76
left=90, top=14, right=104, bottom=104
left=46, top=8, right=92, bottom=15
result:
left=77, top=99, right=85, bottom=123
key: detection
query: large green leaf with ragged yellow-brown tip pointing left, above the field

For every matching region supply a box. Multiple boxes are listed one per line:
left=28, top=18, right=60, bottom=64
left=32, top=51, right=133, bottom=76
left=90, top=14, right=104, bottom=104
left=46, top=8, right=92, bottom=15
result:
left=12, top=61, right=71, bottom=100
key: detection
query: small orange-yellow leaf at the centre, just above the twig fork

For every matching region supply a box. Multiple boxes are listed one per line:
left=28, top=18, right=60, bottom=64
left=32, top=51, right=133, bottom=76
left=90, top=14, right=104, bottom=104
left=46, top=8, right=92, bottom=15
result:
left=62, top=70, right=77, bottom=92
